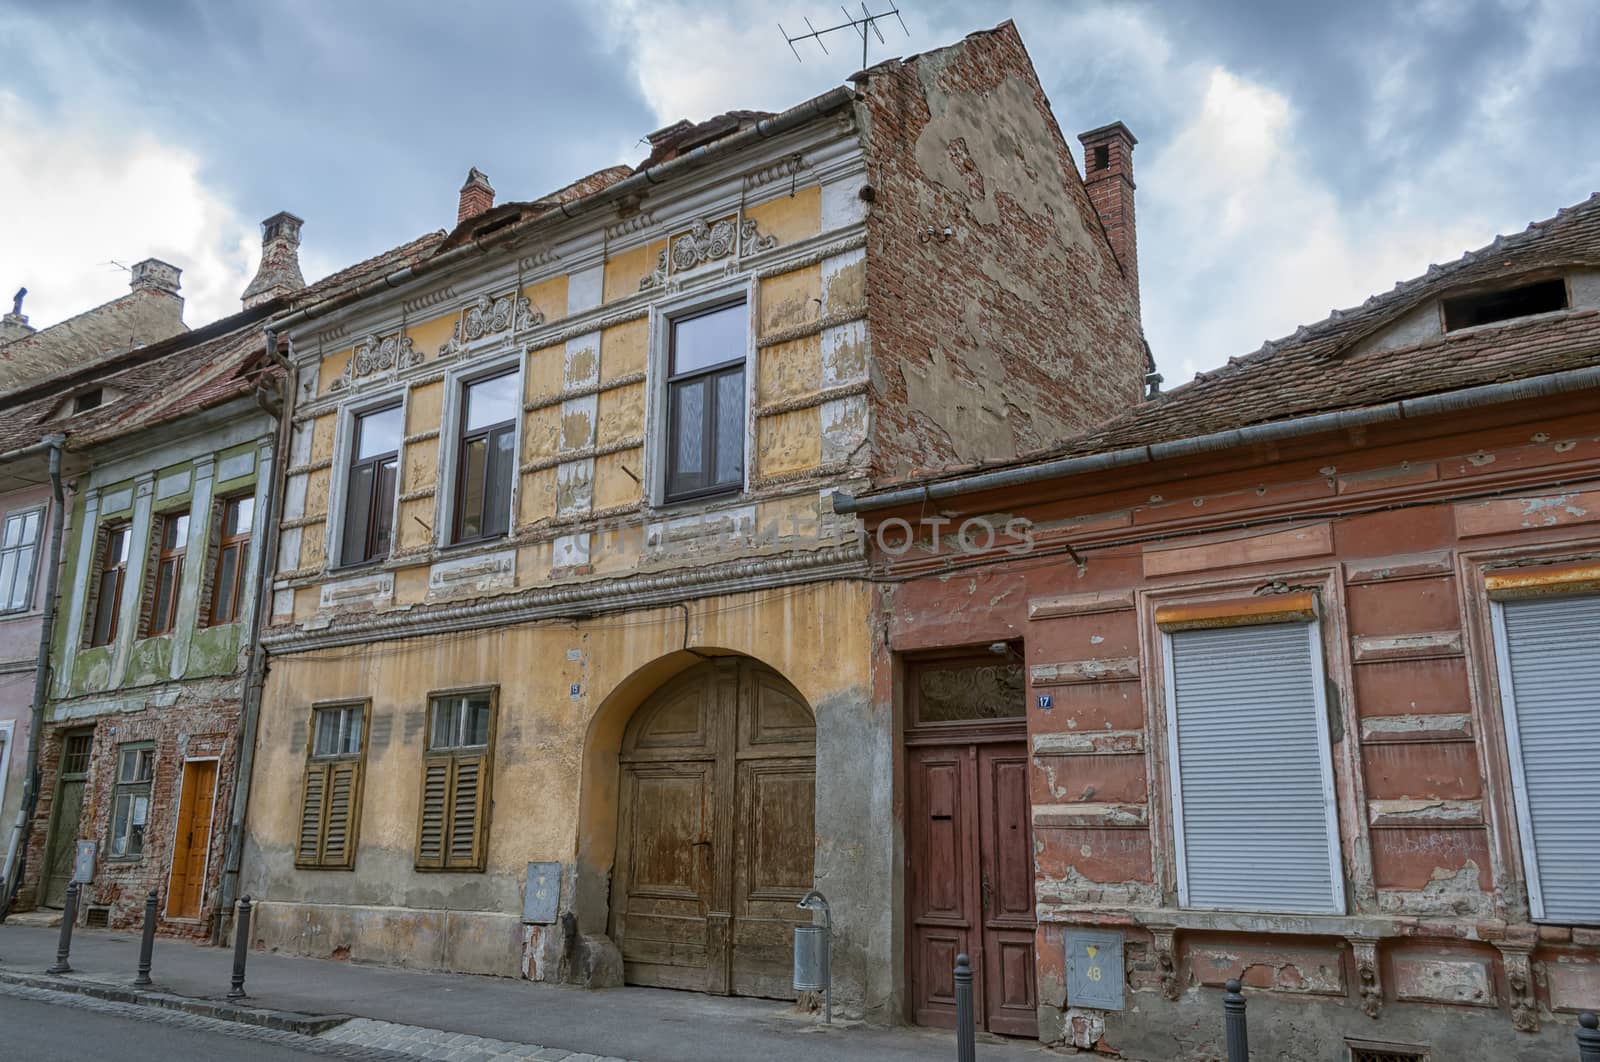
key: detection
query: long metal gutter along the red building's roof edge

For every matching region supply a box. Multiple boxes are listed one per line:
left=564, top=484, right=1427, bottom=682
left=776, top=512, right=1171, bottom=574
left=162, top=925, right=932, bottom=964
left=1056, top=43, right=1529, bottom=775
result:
left=832, top=365, right=1600, bottom=513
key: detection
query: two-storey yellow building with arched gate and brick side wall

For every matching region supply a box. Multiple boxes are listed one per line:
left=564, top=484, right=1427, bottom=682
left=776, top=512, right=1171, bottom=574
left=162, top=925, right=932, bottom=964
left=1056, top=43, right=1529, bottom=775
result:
left=242, top=24, right=1147, bottom=1020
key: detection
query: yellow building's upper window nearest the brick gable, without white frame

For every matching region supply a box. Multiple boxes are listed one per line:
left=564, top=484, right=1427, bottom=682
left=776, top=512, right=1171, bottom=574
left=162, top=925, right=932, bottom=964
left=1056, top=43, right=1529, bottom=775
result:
left=666, top=302, right=749, bottom=501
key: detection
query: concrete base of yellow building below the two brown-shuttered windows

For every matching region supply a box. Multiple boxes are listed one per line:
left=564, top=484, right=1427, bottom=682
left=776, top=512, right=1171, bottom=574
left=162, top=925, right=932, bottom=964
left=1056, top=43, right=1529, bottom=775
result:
left=254, top=900, right=523, bottom=977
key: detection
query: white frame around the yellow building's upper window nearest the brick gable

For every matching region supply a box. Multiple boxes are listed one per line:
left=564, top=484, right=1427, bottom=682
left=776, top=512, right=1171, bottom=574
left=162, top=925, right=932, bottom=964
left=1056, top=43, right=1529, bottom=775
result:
left=645, top=277, right=760, bottom=509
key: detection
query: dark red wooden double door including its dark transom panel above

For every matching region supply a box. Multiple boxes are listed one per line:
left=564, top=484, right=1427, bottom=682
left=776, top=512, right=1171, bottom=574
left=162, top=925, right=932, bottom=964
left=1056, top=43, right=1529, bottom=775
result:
left=906, top=657, right=1038, bottom=1036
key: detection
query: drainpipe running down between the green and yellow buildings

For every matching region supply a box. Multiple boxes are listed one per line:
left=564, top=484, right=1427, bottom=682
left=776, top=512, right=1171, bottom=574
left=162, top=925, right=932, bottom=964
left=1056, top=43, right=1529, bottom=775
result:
left=211, top=328, right=294, bottom=945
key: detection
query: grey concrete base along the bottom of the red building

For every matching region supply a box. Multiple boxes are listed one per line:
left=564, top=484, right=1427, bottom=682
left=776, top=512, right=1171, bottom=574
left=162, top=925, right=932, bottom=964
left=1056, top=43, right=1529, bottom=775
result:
left=1038, top=988, right=1578, bottom=1062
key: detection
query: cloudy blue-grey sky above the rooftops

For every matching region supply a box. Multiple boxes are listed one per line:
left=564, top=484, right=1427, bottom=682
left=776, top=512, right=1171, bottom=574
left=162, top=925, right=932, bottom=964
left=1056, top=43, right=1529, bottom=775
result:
left=0, top=0, right=1600, bottom=382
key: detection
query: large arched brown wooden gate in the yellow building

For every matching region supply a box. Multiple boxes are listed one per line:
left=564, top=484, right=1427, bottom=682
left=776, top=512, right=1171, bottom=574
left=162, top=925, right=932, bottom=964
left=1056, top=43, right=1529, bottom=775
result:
left=611, top=657, right=816, bottom=1000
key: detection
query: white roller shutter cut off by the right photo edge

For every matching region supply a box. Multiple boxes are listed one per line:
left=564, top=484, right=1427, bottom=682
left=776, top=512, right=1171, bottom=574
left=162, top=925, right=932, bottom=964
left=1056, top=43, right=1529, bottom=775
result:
left=1494, top=595, right=1600, bottom=924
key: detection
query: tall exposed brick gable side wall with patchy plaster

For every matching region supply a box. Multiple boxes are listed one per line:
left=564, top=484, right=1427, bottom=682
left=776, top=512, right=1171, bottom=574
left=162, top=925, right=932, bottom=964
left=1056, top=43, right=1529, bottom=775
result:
left=858, top=22, right=1146, bottom=480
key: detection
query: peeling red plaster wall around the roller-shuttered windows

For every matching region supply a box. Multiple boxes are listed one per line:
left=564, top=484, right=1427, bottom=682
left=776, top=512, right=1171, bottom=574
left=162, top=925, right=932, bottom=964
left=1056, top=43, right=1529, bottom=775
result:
left=875, top=395, right=1600, bottom=1062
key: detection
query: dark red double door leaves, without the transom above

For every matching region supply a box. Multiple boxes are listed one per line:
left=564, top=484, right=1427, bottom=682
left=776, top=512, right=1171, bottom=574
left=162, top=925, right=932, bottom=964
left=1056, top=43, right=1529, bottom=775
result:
left=907, top=741, right=1038, bottom=1036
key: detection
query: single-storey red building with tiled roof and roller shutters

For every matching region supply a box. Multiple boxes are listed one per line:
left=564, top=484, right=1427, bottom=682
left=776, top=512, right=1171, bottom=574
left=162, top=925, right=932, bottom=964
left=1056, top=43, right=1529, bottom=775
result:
left=835, top=197, right=1600, bottom=1062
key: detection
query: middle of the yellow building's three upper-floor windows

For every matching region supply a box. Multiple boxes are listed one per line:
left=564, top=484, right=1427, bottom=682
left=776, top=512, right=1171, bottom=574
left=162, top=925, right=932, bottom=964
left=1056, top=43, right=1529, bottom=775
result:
left=454, top=371, right=522, bottom=542
